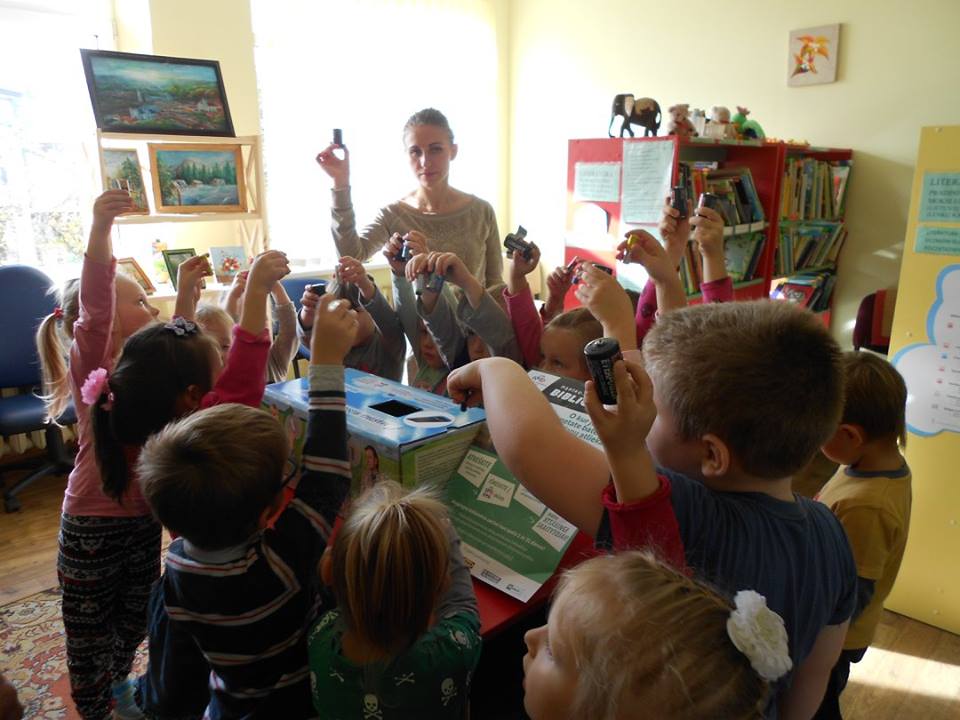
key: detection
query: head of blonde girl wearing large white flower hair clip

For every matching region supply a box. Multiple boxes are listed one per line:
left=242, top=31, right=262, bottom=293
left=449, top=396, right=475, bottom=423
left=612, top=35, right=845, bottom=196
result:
left=523, top=551, right=790, bottom=720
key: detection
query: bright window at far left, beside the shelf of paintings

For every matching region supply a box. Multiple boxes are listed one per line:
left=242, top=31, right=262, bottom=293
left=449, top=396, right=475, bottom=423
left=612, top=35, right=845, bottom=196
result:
left=0, top=0, right=112, bottom=280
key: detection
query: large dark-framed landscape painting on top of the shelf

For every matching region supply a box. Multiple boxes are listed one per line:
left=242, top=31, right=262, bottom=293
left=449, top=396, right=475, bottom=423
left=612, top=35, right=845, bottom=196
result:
left=80, top=50, right=234, bottom=137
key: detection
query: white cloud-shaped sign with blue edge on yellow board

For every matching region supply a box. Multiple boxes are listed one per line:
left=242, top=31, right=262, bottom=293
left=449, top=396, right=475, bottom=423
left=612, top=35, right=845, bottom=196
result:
left=893, top=265, right=960, bottom=437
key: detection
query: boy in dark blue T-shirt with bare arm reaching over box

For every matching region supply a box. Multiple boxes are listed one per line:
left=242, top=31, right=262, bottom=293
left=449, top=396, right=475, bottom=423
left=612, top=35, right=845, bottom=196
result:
left=449, top=300, right=857, bottom=717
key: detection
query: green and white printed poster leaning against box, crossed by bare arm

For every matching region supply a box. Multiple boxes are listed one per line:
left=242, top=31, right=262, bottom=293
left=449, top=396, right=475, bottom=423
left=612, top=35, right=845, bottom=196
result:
left=447, top=370, right=600, bottom=602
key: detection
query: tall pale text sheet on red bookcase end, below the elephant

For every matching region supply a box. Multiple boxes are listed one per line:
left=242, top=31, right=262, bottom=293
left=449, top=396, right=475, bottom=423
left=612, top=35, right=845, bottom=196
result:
left=621, top=140, right=674, bottom=225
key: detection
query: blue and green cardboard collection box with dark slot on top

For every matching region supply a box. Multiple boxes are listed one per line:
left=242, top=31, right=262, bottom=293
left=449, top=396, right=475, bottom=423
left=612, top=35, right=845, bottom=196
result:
left=263, top=368, right=486, bottom=492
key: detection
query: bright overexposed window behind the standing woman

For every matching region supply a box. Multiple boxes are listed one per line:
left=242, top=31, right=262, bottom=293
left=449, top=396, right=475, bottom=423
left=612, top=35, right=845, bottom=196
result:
left=251, top=0, right=503, bottom=267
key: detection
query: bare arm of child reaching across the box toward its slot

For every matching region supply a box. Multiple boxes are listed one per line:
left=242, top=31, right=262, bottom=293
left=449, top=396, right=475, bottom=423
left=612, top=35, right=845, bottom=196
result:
left=447, top=358, right=610, bottom=537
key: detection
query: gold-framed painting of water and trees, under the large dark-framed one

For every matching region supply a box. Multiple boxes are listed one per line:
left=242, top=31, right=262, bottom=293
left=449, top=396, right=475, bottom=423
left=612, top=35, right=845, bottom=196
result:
left=147, top=143, right=247, bottom=213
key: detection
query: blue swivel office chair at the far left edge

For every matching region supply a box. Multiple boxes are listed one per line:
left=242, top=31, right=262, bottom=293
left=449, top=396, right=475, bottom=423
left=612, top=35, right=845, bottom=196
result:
left=0, top=265, right=76, bottom=512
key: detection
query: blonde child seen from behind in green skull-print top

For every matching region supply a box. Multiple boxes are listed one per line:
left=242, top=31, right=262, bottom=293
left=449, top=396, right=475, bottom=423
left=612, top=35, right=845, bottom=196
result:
left=309, top=480, right=480, bottom=720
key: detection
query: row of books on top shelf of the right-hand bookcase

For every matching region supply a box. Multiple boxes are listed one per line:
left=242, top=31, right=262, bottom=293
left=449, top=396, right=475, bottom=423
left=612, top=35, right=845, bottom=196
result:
left=780, top=157, right=853, bottom=220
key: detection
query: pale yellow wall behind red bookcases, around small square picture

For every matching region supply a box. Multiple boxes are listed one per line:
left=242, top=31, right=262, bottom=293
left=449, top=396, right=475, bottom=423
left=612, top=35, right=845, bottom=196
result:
left=509, top=0, right=960, bottom=341
